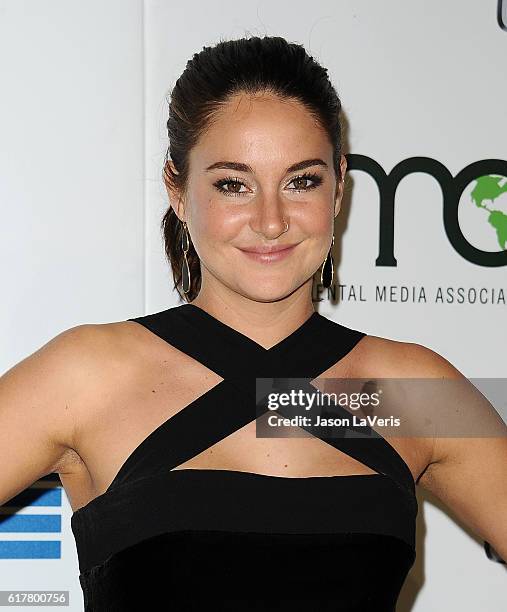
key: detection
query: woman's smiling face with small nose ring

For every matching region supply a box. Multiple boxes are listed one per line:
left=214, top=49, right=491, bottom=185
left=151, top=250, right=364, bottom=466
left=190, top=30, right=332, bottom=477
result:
left=171, top=94, right=346, bottom=302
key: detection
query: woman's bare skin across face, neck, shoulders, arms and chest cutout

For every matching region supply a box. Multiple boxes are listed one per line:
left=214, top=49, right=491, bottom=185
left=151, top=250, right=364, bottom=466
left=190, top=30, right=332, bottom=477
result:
left=0, top=95, right=507, bottom=559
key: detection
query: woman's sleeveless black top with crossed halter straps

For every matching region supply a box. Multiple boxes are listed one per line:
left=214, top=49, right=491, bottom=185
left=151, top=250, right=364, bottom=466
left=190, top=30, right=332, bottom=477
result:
left=71, top=304, right=418, bottom=612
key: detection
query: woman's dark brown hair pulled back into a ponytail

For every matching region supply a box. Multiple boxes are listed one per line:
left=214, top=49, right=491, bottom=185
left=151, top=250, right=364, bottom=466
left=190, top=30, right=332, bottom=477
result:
left=161, top=36, right=342, bottom=302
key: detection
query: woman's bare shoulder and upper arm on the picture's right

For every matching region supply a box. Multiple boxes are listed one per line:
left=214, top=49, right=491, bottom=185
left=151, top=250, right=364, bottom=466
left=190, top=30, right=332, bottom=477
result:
left=358, top=336, right=507, bottom=560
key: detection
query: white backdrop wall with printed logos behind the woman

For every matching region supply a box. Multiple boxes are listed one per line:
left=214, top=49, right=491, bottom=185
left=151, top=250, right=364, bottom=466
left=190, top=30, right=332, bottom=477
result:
left=0, top=0, right=507, bottom=612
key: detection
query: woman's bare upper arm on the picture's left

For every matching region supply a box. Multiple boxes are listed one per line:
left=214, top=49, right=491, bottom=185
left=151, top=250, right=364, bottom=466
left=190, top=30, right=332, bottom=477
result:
left=0, top=325, right=103, bottom=505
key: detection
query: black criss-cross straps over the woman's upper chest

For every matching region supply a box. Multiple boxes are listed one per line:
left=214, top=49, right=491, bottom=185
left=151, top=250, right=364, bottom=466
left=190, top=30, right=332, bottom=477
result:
left=108, top=304, right=415, bottom=496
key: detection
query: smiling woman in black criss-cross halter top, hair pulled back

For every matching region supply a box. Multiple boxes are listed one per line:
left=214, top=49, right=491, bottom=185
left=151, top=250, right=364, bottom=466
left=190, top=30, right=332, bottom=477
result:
left=0, top=37, right=507, bottom=612
